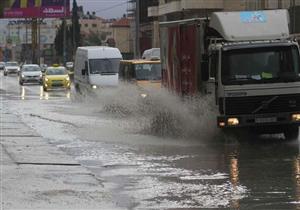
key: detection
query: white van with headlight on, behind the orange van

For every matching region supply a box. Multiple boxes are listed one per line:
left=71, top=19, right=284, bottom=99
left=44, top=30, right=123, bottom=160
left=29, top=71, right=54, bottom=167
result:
left=74, top=46, right=122, bottom=90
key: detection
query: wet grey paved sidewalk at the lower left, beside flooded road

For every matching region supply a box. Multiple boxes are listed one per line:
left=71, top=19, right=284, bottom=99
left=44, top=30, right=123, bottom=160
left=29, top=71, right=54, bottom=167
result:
left=0, top=110, right=118, bottom=210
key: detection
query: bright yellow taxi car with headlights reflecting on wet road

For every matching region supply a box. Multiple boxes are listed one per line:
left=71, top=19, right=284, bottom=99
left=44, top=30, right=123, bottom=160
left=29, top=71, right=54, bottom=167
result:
left=43, top=66, right=71, bottom=91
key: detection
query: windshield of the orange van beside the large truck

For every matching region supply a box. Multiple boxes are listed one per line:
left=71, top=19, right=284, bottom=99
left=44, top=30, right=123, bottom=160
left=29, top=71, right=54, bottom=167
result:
left=135, top=64, right=161, bottom=80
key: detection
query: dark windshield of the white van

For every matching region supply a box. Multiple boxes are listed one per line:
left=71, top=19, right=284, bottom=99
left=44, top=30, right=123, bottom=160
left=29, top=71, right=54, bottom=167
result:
left=89, top=58, right=121, bottom=74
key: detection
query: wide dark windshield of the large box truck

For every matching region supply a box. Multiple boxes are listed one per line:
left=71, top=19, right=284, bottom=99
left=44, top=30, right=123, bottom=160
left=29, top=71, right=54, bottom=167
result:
left=222, top=46, right=300, bottom=85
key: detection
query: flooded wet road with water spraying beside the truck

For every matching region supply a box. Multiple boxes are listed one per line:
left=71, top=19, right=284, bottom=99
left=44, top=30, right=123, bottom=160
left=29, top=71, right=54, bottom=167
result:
left=0, top=73, right=300, bottom=209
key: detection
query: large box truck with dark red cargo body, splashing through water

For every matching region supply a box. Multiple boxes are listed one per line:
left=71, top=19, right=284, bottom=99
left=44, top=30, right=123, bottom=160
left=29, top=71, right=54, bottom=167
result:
left=160, top=10, right=300, bottom=139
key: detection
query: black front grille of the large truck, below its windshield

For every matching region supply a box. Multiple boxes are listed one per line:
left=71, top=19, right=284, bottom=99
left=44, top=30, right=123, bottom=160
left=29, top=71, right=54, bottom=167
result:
left=225, top=94, right=300, bottom=115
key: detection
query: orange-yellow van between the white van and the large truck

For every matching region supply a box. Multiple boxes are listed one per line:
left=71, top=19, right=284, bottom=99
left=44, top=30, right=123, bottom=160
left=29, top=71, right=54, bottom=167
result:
left=119, top=59, right=161, bottom=88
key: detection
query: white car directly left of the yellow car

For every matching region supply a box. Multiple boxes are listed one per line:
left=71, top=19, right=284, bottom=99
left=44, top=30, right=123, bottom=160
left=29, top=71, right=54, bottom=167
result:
left=19, top=64, right=43, bottom=85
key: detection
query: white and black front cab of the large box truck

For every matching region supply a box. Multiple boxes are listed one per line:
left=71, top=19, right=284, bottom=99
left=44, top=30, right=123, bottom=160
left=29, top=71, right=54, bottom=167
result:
left=209, top=10, right=300, bottom=138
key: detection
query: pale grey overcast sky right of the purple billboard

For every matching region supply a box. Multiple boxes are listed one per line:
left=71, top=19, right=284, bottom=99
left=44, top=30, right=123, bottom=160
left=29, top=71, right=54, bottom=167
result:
left=76, top=0, right=127, bottom=18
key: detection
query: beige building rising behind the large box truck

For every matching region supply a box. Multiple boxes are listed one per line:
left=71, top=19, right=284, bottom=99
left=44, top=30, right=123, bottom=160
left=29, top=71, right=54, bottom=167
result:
left=129, top=0, right=300, bottom=54
